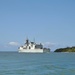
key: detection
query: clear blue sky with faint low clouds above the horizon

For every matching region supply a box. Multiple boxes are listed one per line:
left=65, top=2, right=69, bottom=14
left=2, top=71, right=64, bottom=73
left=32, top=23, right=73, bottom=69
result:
left=0, top=0, right=75, bottom=51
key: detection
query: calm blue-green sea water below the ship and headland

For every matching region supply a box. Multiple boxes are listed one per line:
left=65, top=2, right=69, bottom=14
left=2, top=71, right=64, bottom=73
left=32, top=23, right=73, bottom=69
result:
left=0, top=52, right=75, bottom=75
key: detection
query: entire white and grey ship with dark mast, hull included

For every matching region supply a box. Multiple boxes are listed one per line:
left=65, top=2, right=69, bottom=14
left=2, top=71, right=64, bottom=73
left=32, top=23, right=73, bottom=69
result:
left=19, top=39, right=50, bottom=53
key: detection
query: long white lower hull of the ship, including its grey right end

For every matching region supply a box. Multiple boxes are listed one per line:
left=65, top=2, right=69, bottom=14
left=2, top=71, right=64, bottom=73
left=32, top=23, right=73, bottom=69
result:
left=19, top=49, right=50, bottom=53
